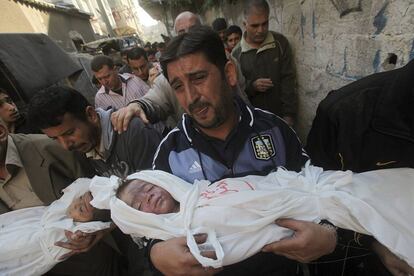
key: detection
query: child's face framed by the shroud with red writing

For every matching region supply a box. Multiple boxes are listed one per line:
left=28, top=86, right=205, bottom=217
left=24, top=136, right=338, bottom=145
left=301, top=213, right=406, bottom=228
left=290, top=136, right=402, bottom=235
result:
left=119, top=180, right=179, bottom=214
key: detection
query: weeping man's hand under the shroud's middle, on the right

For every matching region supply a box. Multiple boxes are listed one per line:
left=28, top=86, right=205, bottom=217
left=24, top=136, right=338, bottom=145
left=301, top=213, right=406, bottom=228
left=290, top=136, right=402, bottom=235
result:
left=262, top=219, right=336, bottom=263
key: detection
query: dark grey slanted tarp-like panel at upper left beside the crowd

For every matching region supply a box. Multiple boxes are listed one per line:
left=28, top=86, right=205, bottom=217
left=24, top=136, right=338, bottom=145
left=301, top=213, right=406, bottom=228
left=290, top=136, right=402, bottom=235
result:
left=0, top=34, right=82, bottom=101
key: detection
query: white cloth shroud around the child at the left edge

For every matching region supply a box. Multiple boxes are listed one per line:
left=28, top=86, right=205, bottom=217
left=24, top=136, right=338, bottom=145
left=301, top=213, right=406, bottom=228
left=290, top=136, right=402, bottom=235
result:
left=0, top=178, right=110, bottom=276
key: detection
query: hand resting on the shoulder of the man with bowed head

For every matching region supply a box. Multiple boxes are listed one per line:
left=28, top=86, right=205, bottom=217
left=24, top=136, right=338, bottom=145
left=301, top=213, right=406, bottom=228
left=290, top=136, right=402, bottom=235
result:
left=111, top=103, right=149, bottom=134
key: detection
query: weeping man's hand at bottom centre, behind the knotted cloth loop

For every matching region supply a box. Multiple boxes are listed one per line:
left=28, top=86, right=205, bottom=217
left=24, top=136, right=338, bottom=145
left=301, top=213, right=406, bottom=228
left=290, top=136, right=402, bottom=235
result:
left=150, top=234, right=221, bottom=275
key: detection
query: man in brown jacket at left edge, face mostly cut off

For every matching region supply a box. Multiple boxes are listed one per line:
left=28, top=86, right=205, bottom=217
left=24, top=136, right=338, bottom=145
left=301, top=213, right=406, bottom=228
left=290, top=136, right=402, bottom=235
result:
left=0, top=119, right=123, bottom=276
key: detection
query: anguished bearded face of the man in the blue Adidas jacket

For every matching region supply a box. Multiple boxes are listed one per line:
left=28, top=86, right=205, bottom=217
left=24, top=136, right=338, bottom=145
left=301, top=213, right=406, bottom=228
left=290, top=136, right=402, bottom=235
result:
left=167, top=53, right=233, bottom=129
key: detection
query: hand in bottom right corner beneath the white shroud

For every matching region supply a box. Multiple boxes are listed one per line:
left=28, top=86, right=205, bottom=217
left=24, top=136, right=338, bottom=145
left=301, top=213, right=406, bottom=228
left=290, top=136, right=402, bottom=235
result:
left=372, top=241, right=414, bottom=276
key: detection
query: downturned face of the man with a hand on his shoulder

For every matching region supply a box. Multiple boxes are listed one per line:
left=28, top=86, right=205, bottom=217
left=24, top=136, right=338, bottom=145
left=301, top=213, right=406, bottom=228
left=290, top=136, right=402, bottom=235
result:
left=42, top=113, right=100, bottom=153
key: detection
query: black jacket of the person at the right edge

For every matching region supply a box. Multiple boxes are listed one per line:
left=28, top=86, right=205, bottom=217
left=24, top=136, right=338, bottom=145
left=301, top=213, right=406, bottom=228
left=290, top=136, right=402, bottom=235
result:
left=306, top=61, right=414, bottom=172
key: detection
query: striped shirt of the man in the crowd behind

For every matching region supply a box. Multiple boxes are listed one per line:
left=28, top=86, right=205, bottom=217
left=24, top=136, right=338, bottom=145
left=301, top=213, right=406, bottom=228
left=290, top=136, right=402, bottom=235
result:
left=95, top=73, right=150, bottom=110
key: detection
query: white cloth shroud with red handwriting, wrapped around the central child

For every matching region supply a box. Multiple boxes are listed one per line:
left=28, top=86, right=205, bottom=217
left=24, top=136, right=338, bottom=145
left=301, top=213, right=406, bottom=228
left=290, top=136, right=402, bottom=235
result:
left=90, top=164, right=414, bottom=267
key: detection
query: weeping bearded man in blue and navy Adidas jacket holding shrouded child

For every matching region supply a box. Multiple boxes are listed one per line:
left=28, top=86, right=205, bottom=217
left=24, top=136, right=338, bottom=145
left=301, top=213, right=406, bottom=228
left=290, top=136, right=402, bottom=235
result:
left=149, top=26, right=316, bottom=275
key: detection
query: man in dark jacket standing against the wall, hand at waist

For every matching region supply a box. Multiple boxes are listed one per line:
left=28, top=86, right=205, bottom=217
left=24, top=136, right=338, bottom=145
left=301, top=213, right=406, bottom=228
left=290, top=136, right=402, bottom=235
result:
left=232, top=0, right=297, bottom=126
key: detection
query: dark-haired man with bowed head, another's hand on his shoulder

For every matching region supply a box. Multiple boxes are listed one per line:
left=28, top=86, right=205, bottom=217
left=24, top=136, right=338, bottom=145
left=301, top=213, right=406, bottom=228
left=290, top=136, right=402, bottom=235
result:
left=28, top=86, right=161, bottom=275
